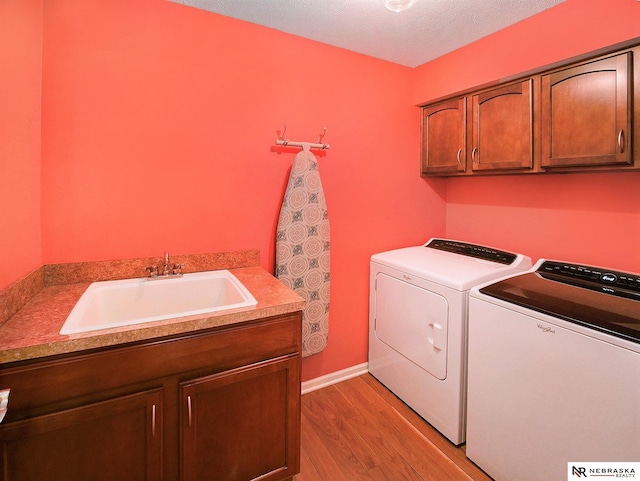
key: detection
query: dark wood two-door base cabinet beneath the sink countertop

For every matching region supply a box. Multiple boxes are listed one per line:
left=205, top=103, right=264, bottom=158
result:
left=0, top=312, right=301, bottom=481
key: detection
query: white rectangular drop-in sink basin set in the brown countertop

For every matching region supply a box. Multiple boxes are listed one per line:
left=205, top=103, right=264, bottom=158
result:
left=60, top=270, right=258, bottom=334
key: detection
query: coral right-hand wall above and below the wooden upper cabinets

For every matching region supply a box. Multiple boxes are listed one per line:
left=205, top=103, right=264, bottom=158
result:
left=414, top=0, right=640, bottom=272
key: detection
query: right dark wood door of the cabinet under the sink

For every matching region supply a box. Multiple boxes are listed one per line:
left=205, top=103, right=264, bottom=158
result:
left=180, top=355, right=300, bottom=481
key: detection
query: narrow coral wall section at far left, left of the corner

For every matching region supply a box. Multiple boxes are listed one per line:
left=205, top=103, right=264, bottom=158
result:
left=0, top=0, right=42, bottom=289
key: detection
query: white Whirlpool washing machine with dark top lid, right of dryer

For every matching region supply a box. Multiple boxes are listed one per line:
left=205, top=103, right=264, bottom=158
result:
left=466, top=259, right=640, bottom=481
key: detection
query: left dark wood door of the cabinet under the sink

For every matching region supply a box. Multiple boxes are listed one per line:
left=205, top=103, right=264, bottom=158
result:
left=0, top=390, right=162, bottom=481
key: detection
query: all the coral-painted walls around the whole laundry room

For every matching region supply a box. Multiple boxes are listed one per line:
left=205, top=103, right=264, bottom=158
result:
left=0, top=0, right=640, bottom=379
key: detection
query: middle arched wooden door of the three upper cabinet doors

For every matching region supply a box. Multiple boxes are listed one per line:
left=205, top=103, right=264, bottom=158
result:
left=471, top=79, right=533, bottom=171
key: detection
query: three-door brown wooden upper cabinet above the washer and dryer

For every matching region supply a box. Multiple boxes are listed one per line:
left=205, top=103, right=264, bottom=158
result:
left=421, top=38, right=640, bottom=176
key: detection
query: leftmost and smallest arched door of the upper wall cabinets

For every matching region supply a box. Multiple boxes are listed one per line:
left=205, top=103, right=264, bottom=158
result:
left=421, top=97, right=467, bottom=174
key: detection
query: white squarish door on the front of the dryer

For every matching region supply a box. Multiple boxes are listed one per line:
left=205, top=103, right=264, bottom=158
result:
left=375, top=273, right=449, bottom=380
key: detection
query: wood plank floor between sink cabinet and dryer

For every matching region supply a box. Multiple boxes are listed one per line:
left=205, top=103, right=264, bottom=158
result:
left=294, top=374, right=491, bottom=481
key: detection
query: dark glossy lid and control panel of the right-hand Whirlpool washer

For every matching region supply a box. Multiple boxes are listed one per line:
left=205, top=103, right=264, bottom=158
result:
left=480, top=259, right=640, bottom=343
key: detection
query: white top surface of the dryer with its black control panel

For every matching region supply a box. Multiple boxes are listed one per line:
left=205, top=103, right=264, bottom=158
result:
left=371, top=239, right=531, bottom=291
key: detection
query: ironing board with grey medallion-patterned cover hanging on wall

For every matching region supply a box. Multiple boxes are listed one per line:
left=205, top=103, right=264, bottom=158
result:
left=276, top=145, right=330, bottom=357
